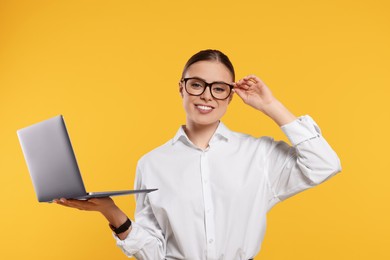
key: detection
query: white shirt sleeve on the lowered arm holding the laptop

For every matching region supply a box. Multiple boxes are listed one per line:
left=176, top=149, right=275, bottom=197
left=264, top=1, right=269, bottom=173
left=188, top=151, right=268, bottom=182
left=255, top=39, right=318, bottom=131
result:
left=114, top=161, right=166, bottom=260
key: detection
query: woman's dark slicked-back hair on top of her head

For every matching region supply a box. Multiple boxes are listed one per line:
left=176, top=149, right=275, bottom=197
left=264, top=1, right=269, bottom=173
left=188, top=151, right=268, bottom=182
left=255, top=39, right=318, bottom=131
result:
left=181, top=49, right=235, bottom=81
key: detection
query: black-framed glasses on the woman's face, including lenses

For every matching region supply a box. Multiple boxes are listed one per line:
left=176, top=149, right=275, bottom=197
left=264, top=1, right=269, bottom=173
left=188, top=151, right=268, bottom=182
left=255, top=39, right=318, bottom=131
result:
left=181, top=78, right=234, bottom=100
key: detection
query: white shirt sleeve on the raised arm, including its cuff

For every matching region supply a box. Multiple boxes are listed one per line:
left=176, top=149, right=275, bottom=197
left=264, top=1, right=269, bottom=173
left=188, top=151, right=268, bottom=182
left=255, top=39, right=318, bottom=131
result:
left=265, top=116, right=341, bottom=201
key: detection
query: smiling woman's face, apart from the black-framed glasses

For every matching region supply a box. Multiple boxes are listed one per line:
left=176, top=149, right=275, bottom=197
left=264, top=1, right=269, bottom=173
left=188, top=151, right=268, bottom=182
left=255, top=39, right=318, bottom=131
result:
left=180, top=61, right=233, bottom=126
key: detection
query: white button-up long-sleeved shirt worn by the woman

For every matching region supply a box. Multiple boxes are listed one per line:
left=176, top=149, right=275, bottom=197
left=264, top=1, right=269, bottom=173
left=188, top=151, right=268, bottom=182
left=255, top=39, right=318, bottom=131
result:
left=114, top=116, right=341, bottom=260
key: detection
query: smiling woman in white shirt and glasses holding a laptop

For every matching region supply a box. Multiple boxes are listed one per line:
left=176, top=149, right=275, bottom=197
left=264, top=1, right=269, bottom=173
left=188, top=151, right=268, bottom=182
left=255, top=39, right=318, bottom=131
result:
left=56, top=50, right=341, bottom=260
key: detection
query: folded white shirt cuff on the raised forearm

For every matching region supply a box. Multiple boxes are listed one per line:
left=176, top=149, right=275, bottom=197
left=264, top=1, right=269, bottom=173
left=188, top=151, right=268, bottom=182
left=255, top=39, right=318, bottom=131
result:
left=280, top=115, right=321, bottom=146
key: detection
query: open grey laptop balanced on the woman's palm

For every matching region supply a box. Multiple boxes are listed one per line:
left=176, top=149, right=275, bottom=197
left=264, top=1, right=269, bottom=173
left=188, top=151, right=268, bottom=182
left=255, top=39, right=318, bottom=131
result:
left=17, top=115, right=157, bottom=202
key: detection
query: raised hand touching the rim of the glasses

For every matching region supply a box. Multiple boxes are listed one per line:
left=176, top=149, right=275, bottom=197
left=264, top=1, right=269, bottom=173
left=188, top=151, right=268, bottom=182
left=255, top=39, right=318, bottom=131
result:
left=233, top=75, right=276, bottom=112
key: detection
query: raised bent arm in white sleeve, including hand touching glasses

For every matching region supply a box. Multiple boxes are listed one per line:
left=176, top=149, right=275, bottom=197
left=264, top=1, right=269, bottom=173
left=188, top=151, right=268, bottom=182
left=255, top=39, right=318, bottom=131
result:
left=234, top=75, right=341, bottom=200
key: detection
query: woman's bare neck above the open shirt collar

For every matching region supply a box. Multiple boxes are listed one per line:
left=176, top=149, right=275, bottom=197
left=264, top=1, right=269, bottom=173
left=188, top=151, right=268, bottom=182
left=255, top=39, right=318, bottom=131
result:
left=184, top=120, right=219, bottom=149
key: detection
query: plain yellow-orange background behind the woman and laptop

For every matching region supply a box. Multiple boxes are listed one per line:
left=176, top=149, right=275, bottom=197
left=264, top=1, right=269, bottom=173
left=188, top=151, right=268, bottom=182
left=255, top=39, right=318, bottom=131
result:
left=0, top=0, right=390, bottom=260
